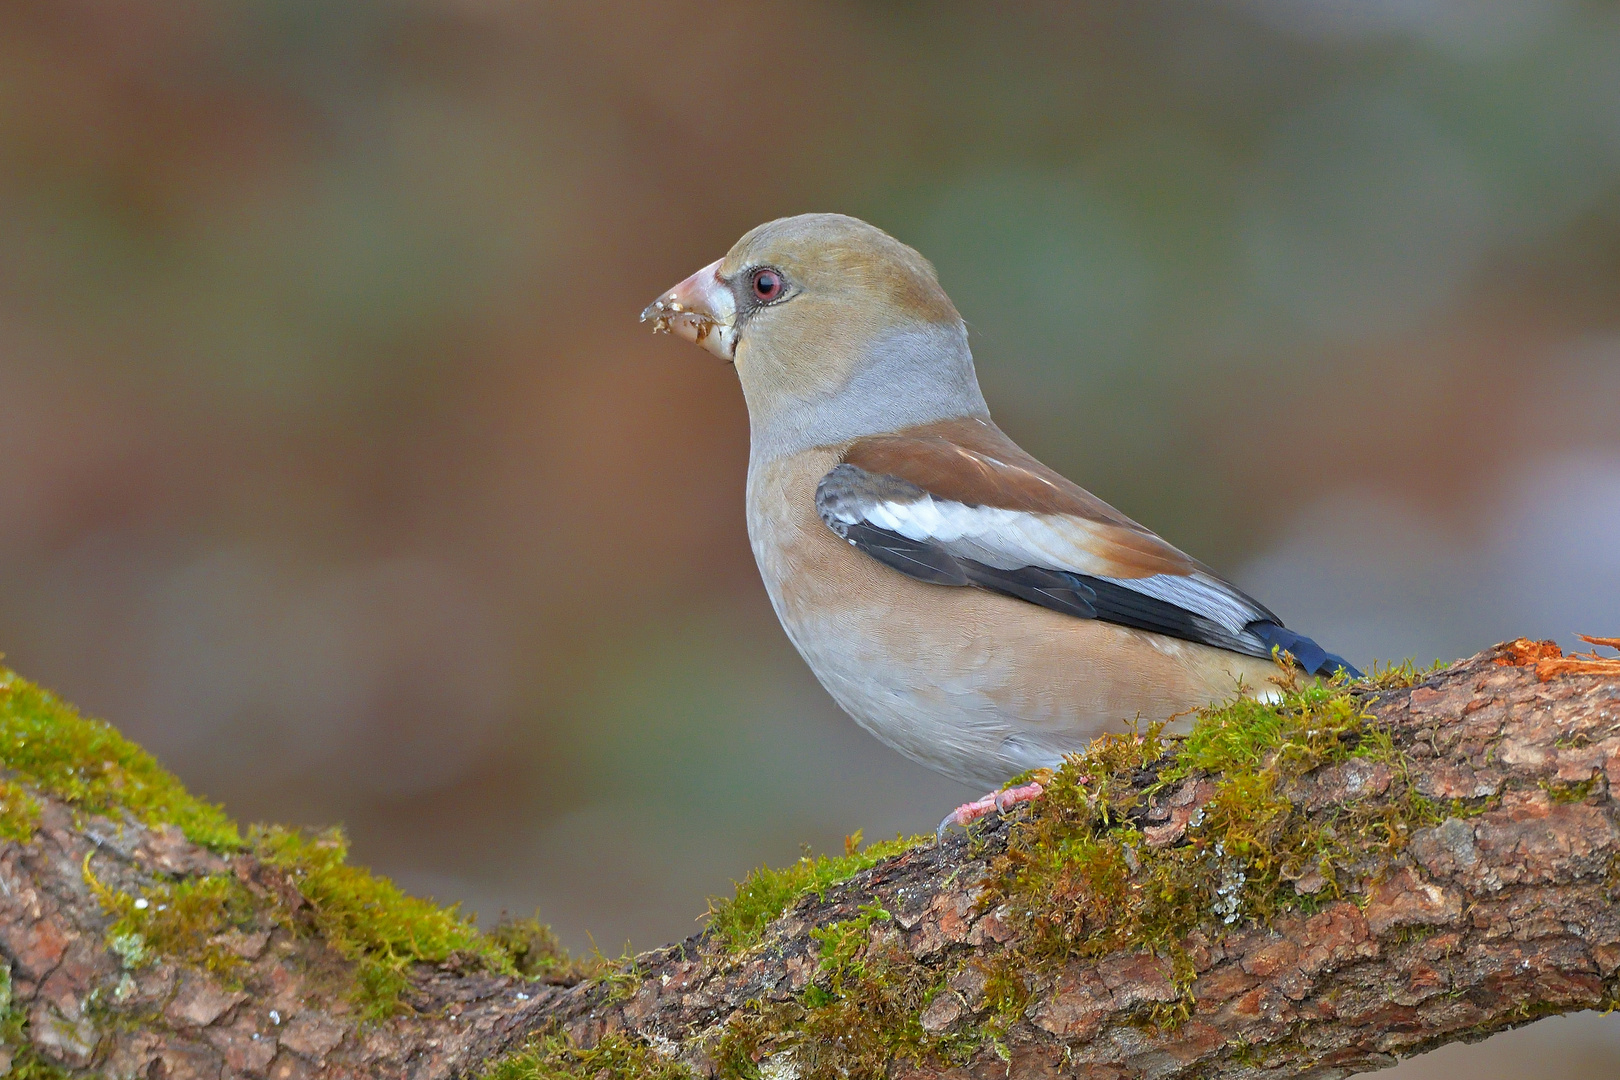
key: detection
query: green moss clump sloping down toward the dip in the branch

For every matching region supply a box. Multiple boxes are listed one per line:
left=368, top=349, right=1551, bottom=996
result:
left=249, top=827, right=517, bottom=1018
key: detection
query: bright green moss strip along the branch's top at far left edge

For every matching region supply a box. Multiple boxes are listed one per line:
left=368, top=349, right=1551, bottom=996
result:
left=0, top=669, right=241, bottom=852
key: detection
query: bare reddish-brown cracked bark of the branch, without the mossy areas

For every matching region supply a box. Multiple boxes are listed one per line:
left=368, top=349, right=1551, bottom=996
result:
left=0, top=641, right=1620, bottom=1080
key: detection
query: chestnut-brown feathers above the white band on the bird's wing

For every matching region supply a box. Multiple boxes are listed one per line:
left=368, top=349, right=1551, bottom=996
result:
left=844, top=416, right=1202, bottom=578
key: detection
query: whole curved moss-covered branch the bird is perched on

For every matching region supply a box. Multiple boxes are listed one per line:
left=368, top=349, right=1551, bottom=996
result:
left=0, top=640, right=1620, bottom=1080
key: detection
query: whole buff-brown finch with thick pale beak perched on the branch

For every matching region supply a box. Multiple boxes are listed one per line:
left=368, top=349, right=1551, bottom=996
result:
left=642, top=214, right=1361, bottom=836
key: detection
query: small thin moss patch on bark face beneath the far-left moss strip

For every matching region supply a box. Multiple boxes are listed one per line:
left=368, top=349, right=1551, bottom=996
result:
left=84, top=857, right=256, bottom=984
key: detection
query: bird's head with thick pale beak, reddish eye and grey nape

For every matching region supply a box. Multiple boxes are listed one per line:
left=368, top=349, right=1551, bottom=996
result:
left=642, top=214, right=983, bottom=450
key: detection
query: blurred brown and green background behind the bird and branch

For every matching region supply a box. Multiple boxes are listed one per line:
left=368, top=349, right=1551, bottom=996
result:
left=0, top=0, right=1620, bottom=1080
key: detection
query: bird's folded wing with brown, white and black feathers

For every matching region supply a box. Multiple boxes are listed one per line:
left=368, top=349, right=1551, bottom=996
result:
left=816, top=418, right=1359, bottom=675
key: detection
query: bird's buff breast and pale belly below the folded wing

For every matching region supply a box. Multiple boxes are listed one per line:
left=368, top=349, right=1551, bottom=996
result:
left=748, top=460, right=1270, bottom=785
